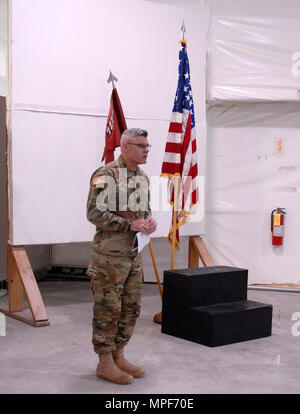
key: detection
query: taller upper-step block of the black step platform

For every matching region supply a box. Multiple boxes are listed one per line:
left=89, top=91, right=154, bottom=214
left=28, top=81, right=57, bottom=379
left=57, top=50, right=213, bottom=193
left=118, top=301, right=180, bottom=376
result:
left=162, top=266, right=248, bottom=340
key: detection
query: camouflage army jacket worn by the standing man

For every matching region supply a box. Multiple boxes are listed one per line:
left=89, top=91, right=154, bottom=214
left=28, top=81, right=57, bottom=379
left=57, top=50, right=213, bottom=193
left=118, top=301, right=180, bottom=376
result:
left=87, top=156, right=151, bottom=257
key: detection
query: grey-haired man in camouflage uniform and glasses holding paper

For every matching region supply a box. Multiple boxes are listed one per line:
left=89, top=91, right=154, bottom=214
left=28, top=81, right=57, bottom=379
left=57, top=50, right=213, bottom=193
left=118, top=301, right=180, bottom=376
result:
left=87, top=128, right=156, bottom=384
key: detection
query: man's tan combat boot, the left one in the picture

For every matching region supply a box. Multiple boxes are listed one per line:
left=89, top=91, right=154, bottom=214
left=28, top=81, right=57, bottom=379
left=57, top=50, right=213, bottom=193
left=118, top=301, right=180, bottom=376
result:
left=96, top=352, right=133, bottom=384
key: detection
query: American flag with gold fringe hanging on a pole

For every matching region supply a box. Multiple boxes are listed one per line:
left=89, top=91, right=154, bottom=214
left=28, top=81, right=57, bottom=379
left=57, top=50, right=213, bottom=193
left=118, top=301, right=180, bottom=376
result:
left=161, top=40, right=199, bottom=250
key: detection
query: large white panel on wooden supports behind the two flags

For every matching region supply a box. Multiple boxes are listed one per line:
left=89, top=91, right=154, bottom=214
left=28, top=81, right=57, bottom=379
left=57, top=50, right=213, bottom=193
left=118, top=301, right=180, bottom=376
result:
left=10, top=0, right=206, bottom=244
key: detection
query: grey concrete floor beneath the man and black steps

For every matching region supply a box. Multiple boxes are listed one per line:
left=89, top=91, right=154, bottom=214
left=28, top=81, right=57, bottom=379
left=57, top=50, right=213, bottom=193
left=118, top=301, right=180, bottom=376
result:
left=0, top=281, right=300, bottom=394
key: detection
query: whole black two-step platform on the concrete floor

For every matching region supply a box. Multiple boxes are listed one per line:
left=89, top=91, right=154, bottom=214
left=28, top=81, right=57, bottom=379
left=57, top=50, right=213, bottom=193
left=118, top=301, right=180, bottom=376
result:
left=162, top=266, right=272, bottom=347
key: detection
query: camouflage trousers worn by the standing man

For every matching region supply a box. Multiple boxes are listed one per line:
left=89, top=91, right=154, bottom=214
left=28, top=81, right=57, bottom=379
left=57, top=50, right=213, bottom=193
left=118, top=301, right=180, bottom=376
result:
left=88, top=253, right=143, bottom=354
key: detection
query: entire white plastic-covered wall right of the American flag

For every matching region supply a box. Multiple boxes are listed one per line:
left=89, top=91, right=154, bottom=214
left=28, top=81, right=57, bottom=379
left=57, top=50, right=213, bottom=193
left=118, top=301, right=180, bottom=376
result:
left=205, top=0, right=300, bottom=284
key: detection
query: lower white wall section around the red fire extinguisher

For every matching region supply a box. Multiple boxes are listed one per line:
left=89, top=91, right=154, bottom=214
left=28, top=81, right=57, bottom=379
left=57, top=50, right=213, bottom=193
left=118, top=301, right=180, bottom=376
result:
left=205, top=104, right=300, bottom=283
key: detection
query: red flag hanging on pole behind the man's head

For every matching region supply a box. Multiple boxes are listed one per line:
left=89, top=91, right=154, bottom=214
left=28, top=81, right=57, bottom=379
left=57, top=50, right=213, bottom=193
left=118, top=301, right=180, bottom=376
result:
left=101, top=88, right=127, bottom=164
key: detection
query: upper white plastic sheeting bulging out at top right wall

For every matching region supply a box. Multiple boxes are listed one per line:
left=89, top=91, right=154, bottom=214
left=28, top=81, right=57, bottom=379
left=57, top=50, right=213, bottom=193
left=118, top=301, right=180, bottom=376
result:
left=207, top=0, right=300, bottom=102
